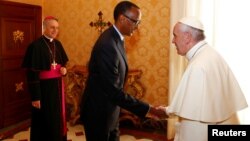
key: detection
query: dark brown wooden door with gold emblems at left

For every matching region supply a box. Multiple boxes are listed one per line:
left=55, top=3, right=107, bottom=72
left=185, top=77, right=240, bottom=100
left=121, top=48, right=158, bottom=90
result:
left=0, top=1, right=42, bottom=140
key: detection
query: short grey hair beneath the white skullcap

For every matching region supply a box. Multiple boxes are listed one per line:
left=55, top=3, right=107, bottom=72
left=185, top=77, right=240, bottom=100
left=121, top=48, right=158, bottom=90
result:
left=180, top=23, right=205, bottom=42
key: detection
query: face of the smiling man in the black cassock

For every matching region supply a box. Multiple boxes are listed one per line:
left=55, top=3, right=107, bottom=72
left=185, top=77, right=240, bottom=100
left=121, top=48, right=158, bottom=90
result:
left=44, top=19, right=59, bottom=39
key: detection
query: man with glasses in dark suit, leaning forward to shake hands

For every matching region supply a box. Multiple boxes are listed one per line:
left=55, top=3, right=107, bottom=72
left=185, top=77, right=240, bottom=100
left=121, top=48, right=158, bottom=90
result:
left=81, top=1, right=165, bottom=141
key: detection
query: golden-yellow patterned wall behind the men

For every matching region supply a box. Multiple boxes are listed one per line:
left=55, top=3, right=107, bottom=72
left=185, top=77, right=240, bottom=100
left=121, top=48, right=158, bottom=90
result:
left=5, top=0, right=170, bottom=105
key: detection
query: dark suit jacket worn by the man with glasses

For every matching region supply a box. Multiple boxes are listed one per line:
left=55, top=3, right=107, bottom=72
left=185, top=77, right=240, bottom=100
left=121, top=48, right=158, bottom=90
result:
left=81, top=26, right=149, bottom=129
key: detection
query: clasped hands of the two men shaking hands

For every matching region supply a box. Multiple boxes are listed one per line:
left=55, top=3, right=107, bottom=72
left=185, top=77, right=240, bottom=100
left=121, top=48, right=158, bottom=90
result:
left=147, top=106, right=169, bottom=120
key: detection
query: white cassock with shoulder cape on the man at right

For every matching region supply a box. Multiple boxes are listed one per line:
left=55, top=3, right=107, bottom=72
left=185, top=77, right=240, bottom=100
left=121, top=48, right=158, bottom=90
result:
left=167, top=41, right=247, bottom=141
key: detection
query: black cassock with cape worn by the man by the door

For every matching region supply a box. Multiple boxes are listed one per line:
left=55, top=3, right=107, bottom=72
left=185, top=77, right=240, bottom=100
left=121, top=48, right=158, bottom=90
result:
left=22, top=36, right=68, bottom=141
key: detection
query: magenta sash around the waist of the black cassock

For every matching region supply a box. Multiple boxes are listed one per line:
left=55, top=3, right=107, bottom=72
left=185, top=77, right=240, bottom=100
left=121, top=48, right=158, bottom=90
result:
left=39, top=64, right=67, bottom=135
